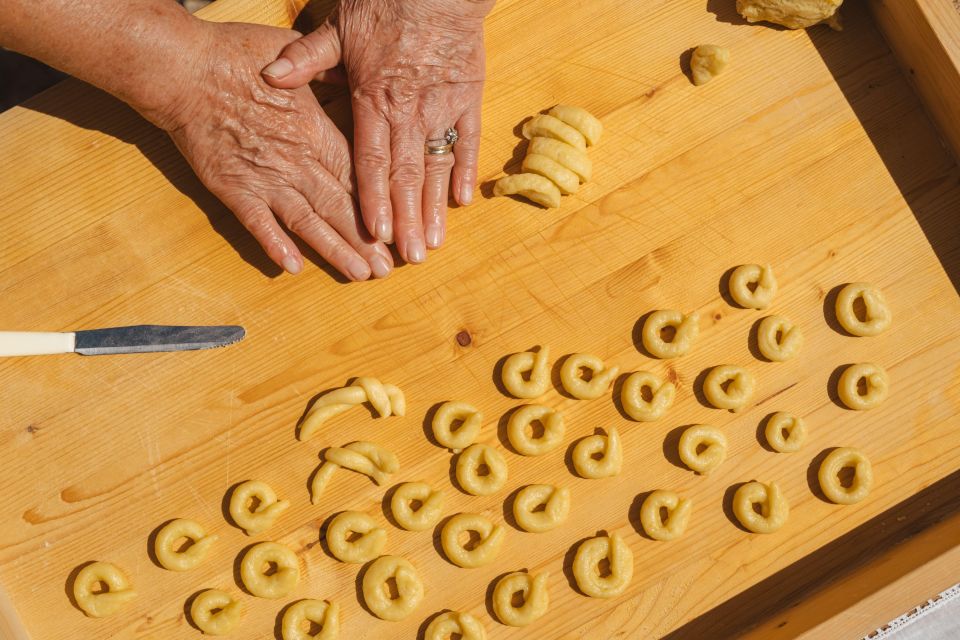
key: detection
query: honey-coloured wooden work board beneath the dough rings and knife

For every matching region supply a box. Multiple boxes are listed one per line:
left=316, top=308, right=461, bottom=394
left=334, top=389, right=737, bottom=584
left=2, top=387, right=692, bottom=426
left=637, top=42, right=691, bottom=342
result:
left=0, top=0, right=960, bottom=640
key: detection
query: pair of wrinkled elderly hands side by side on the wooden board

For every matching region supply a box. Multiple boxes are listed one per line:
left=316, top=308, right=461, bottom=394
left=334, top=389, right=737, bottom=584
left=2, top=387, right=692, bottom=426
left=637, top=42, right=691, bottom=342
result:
left=158, top=0, right=493, bottom=280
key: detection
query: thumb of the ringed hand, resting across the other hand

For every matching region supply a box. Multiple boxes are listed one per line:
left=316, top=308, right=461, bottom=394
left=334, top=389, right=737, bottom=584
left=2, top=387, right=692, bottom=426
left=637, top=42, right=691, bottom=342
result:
left=260, top=22, right=341, bottom=89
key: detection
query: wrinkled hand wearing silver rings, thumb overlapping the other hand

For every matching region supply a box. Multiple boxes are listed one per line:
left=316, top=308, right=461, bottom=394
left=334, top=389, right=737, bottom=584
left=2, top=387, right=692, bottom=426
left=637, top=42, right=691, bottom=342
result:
left=263, top=0, right=493, bottom=263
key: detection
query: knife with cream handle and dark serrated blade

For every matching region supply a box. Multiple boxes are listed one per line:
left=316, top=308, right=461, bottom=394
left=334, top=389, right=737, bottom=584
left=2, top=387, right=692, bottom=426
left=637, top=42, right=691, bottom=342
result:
left=0, top=324, right=246, bottom=356
